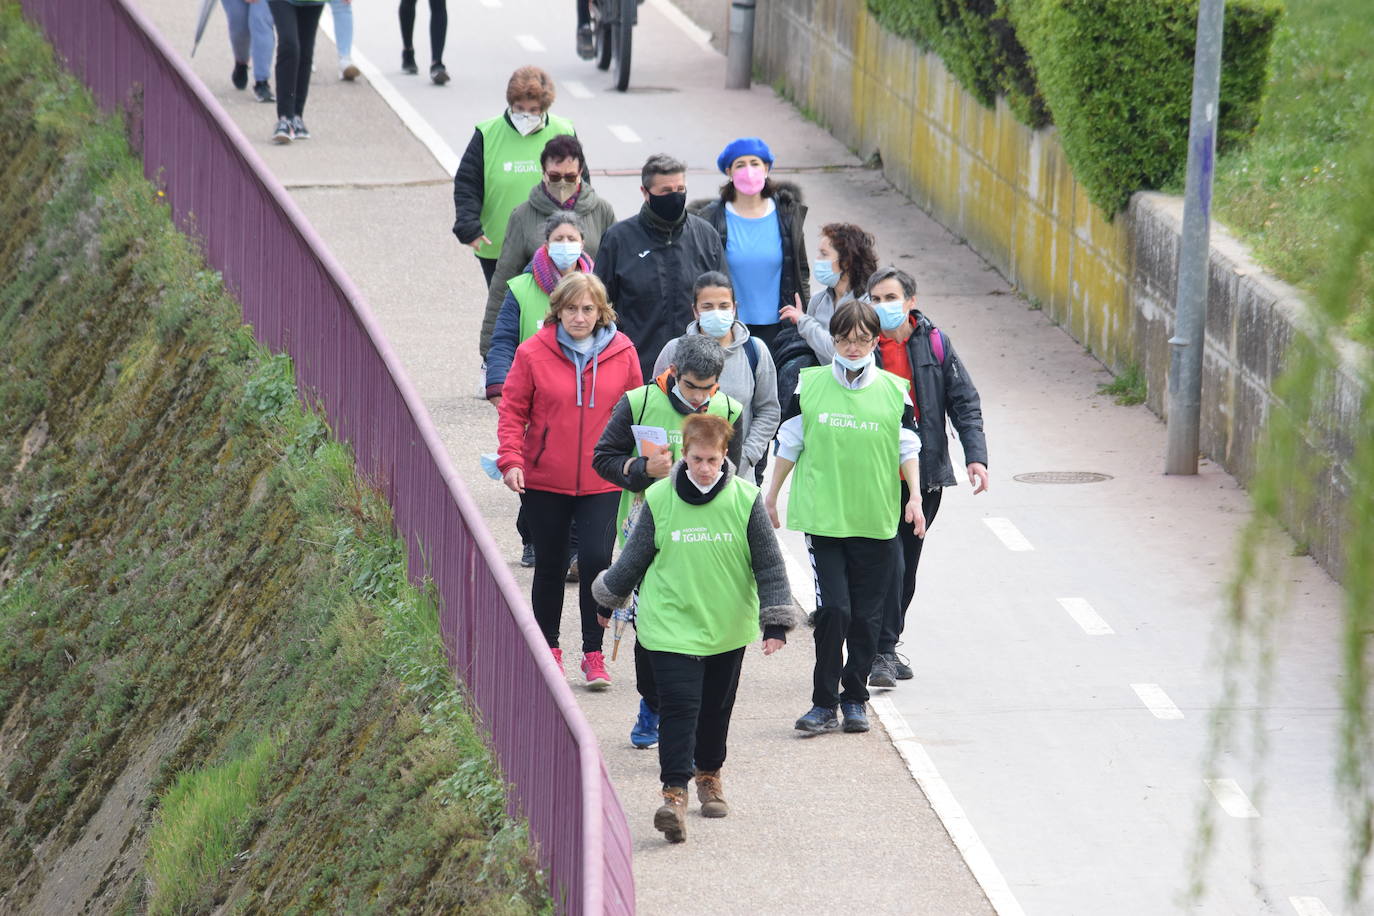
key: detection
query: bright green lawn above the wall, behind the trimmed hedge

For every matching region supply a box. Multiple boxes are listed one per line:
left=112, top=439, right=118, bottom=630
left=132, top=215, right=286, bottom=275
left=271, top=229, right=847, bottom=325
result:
left=1215, top=0, right=1374, bottom=343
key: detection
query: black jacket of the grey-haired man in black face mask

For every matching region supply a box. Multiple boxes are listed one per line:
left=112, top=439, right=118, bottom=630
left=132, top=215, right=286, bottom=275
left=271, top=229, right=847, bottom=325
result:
left=592, top=205, right=730, bottom=382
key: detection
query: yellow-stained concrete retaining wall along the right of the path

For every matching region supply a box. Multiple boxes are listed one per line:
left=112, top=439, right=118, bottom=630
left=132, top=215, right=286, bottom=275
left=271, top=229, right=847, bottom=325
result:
left=683, top=0, right=1364, bottom=578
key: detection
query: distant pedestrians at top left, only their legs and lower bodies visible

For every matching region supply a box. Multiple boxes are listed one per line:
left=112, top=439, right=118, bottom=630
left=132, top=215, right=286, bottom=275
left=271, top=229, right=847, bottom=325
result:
left=220, top=0, right=449, bottom=144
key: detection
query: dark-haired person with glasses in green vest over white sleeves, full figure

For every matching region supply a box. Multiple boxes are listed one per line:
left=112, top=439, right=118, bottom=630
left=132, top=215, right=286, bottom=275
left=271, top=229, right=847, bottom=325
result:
left=765, top=301, right=926, bottom=735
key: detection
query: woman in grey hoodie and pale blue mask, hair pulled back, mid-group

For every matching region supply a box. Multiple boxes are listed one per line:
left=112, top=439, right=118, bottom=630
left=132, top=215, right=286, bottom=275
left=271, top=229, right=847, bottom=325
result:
left=654, top=271, right=782, bottom=483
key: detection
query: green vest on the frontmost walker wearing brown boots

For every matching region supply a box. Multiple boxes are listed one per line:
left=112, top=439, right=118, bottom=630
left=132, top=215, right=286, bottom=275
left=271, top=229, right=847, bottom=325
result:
left=635, top=471, right=758, bottom=655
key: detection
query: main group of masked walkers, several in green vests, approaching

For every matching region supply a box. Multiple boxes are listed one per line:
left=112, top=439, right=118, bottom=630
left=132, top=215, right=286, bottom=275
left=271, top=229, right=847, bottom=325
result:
left=453, top=67, right=988, bottom=842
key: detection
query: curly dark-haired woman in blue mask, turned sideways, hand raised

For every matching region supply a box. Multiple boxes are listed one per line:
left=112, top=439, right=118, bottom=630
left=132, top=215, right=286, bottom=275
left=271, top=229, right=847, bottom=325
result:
left=774, top=222, right=878, bottom=405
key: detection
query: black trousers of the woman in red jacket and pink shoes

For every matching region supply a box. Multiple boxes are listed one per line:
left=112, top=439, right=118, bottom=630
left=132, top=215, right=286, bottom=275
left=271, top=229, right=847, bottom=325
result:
left=521, top=490, right=620, bottom=652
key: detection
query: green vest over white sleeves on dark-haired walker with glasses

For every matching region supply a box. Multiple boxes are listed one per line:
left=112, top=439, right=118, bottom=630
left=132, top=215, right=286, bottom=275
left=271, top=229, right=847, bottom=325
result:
left=787, top=365, right=908, bottom=540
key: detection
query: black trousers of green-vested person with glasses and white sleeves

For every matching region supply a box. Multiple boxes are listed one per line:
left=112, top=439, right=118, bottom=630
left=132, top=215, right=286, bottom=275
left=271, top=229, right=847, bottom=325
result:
left=807, top=534, right=901, bottom=709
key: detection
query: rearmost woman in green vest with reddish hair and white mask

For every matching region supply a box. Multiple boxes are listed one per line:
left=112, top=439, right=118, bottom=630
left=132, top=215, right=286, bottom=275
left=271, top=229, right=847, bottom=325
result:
left=453, top=66, right=577, bottom=287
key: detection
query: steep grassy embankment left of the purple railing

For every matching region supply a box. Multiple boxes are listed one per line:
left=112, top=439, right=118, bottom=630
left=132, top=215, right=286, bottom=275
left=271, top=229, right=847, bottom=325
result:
left=0, top=3, right=550, bottom=913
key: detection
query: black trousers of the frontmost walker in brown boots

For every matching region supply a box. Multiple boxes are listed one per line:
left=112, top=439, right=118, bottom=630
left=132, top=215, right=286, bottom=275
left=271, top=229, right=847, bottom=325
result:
left=646, top=647, right=745, bottom=787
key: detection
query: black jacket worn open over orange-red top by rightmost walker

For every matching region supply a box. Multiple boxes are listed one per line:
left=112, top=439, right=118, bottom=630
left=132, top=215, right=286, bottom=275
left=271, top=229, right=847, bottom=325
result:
left=879, top=310, right=988, bottom=492
